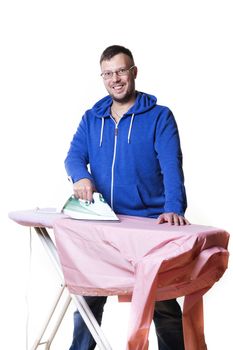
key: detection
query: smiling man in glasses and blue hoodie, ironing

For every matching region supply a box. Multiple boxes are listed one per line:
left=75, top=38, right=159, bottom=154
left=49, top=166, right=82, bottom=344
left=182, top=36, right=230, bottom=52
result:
left=65, top=45, right=188, bottom=350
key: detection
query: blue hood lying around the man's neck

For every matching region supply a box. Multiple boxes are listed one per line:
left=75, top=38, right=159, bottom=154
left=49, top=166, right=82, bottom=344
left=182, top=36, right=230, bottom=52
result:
left=92, top=91, right=157, bottom=118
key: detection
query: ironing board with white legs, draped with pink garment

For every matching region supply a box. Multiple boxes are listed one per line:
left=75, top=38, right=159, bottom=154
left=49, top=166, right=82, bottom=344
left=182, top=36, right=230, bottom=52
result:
left=9, top=209, right=229, bottom=350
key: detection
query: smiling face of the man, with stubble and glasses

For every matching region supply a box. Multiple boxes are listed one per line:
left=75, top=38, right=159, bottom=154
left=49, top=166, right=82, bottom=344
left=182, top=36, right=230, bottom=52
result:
left=101, top=53, right=137, bottom=103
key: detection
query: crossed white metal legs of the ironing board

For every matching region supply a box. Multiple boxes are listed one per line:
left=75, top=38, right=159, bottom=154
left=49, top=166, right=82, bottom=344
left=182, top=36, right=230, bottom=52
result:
left=32, top=227, right=112, bottom=350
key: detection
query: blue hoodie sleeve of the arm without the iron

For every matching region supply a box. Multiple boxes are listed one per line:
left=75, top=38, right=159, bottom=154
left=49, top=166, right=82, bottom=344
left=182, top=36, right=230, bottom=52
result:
left=155, top=107, right=187, bottom=215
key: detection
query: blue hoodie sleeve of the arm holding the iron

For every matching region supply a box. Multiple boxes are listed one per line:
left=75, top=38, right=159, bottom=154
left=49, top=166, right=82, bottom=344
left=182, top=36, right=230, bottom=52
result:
left=65, top=115, right=93, bottom=183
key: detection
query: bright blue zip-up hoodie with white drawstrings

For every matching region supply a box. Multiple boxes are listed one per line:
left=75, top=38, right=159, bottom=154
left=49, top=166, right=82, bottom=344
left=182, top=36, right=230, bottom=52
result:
left=65, top=92, right=186, bottom=218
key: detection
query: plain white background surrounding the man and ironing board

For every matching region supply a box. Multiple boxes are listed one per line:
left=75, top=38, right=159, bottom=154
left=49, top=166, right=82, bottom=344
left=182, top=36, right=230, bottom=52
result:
left=0, top=0, right=233, bottom=350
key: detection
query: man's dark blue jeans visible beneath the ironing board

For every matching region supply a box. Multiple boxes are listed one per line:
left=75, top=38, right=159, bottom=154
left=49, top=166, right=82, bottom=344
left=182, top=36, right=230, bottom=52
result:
left=69, top=297, right=184, bottom=350
